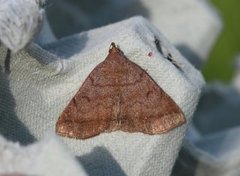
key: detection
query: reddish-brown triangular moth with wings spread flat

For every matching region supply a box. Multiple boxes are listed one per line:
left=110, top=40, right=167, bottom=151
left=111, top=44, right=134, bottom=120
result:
left=56, top=43, right=185, bottom=139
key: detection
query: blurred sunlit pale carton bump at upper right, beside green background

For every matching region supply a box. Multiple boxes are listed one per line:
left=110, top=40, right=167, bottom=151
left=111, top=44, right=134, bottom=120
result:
left=141, top=0, right=222, bottom=60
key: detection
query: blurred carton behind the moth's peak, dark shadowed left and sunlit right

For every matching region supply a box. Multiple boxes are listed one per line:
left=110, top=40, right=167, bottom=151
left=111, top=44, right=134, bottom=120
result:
left=46, top=0, right=222, bottom=68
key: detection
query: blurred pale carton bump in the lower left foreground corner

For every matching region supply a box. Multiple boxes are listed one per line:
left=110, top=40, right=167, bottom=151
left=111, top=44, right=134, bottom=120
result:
left=0, top=135, right=86, bottom=176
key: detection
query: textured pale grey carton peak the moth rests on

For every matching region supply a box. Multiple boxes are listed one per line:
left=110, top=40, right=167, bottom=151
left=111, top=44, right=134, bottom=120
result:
left=0, top=17, right=204, bottom=176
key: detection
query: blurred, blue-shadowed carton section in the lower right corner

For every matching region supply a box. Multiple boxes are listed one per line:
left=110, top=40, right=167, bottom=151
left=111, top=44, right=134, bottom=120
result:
left=176, top=83, right=240, bottom=176
